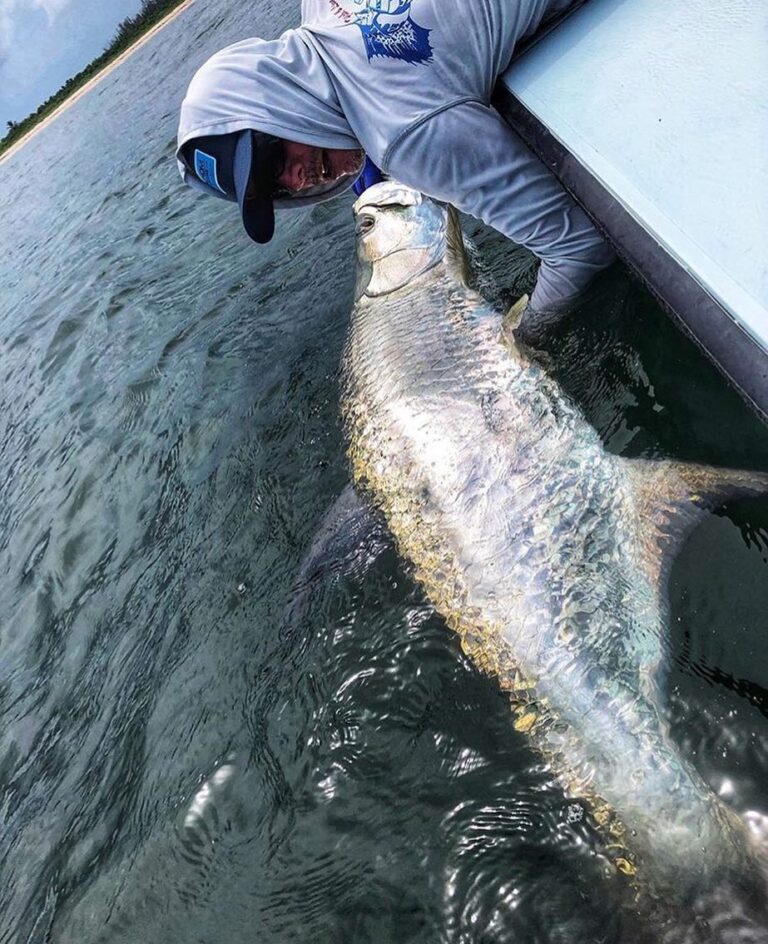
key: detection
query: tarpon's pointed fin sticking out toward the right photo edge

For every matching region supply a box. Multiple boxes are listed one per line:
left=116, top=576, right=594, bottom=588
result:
left=622, top=459, right=768, bottom=583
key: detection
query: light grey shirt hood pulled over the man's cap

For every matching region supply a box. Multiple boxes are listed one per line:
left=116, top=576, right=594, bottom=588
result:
left=176, top=28, right=360, bottom=206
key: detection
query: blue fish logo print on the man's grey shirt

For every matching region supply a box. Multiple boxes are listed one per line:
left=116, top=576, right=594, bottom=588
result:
left=354, top=0, right=432, bottom=63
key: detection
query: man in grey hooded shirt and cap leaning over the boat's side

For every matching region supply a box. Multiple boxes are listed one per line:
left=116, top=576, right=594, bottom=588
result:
left=177, top=0, right=614, bottom=321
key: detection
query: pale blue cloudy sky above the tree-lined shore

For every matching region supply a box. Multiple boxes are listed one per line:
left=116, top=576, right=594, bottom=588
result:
left=0, top=0, right=146, bottom=129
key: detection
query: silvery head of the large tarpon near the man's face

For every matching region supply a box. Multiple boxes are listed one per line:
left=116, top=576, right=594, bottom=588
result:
left=353, top=180, right=463, bottom=299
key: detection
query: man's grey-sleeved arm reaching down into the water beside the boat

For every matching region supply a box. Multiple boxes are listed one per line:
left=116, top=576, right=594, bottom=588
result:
left=383, top=102, right=615, bottom=311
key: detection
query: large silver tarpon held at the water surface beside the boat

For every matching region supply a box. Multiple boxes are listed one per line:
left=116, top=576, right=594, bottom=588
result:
left=342, top=183, right=768, bottom=940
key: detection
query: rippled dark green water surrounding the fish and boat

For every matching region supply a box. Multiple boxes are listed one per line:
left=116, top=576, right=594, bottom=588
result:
left=0, top=0, right=768, bottom=944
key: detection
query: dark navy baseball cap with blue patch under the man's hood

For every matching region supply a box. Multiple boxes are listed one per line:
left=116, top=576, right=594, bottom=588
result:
left=181, top=128, right=284, bottom=243
